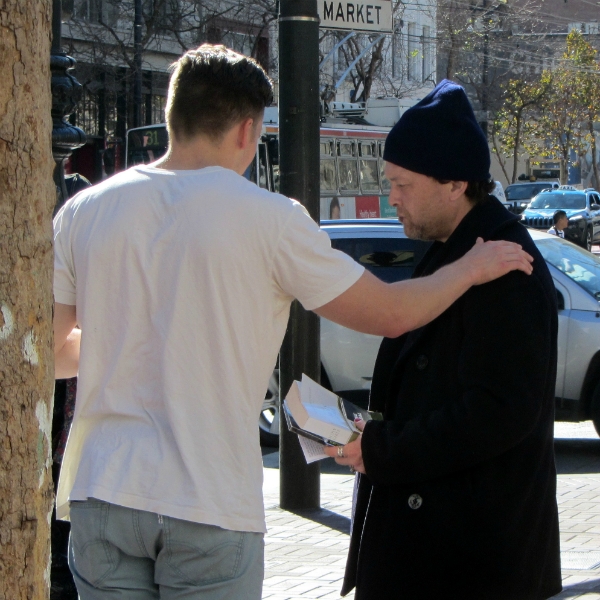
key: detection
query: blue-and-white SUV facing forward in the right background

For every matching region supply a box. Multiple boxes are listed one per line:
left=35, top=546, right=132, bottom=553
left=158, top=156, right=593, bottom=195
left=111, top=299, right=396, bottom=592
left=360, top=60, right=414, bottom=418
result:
left=521, top=185, right=600, bottom=250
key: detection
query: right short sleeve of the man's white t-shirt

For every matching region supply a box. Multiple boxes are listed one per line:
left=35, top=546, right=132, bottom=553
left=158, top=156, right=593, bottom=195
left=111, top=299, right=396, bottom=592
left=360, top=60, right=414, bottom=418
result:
left=273, top=202, right=365, bottom=310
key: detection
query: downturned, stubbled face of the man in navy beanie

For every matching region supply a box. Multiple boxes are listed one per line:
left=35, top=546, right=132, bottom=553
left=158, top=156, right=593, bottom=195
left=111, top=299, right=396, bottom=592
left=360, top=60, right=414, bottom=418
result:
left=385, top=162, right=454, bottom=241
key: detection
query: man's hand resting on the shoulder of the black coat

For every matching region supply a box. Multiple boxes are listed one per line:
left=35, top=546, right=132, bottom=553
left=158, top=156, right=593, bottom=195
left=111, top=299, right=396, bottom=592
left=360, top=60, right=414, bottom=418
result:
left=454, top=238, right=533, bottom=285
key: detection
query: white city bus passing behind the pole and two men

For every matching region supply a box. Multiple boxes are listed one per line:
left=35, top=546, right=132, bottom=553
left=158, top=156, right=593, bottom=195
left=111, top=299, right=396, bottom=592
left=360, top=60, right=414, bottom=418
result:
left=126, top=107, right=396, bottom=219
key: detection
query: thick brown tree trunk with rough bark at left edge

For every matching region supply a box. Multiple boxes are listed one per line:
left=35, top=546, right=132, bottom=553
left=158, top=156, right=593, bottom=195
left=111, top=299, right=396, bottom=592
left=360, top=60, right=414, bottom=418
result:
left=0, top=0, right=56, bottom=600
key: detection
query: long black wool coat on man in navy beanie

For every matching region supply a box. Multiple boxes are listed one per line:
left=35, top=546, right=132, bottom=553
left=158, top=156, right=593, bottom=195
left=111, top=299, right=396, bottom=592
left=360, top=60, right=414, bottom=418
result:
left=342, top=197, right=561, bottom=600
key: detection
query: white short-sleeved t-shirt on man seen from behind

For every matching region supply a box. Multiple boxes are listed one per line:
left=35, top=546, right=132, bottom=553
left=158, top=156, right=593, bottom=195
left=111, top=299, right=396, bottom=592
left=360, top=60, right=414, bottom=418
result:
left=54, top=166, right=364, bottom=532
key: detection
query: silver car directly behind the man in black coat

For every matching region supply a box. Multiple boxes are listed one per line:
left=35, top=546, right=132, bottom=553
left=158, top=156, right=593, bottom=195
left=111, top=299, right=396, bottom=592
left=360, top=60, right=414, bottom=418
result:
left=260, top=219, right=600, bottom=445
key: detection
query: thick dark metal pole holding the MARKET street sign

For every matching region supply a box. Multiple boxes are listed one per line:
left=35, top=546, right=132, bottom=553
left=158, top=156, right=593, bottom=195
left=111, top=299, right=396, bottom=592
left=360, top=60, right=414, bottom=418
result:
left=279, top=0, right=321, bottom=510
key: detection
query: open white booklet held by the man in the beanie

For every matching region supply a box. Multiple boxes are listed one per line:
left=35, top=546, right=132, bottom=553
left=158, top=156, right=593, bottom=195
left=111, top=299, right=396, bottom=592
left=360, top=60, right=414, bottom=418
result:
left=283, top=374, right=383, bottom=446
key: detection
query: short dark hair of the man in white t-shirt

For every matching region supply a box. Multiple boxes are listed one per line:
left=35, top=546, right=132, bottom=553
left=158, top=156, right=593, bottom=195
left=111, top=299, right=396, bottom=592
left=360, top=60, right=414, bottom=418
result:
left=166, top=44, right=273, bottom=142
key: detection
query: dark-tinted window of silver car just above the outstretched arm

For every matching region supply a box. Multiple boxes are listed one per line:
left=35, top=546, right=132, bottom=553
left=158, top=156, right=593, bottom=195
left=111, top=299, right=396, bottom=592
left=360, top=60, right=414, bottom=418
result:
left=331, top=238, right=430, bottom=283
